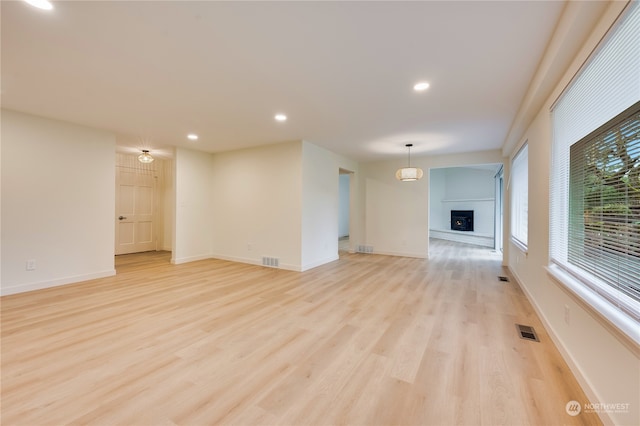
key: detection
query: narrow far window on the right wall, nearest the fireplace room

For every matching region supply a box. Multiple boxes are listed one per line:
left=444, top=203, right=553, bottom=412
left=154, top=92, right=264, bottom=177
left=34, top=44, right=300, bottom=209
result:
left=511, top=143, right=529, bottom=251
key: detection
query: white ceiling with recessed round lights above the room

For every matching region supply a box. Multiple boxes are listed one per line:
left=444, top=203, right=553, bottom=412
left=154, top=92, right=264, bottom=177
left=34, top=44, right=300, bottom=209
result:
left=1, top=0, right=564, bottom=161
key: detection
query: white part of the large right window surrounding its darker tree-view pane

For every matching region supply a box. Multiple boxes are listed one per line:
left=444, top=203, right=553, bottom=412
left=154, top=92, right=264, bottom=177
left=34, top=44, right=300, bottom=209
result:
left=547, top=2, right=640, bottom=344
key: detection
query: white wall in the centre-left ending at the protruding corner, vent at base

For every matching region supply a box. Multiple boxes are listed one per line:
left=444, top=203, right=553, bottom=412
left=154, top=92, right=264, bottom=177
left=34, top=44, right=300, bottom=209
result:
left=208, top=142, right=302, bottom=270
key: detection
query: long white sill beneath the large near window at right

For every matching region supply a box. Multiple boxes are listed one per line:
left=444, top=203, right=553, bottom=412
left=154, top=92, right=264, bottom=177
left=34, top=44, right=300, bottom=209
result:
left=545, top=265, right=640, bottom=354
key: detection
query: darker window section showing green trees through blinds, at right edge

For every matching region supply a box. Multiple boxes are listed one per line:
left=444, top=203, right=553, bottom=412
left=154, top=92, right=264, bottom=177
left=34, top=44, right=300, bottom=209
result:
left=568, top=102, right=640, bottom=302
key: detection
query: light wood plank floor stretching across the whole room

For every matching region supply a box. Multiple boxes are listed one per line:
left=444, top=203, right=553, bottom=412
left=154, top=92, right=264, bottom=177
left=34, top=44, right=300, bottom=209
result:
left=1, top=240, right=600, bottom=426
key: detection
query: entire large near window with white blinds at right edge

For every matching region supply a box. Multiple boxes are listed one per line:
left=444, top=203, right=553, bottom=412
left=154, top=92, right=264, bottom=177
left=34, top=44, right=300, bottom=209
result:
left=549, top=2, right=640, bottom=343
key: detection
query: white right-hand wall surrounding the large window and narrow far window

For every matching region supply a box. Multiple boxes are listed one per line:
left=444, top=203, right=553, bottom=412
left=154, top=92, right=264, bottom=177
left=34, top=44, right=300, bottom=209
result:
left=505, top=2, right=640, bottom=425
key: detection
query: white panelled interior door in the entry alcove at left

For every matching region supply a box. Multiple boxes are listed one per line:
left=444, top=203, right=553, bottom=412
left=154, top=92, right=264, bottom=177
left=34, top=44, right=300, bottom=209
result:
left=115, top=169, right=156, bottom=254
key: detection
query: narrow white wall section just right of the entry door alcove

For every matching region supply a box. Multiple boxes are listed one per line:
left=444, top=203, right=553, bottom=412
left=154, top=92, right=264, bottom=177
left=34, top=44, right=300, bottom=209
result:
left=171, top=148, right=217, bottom=263
